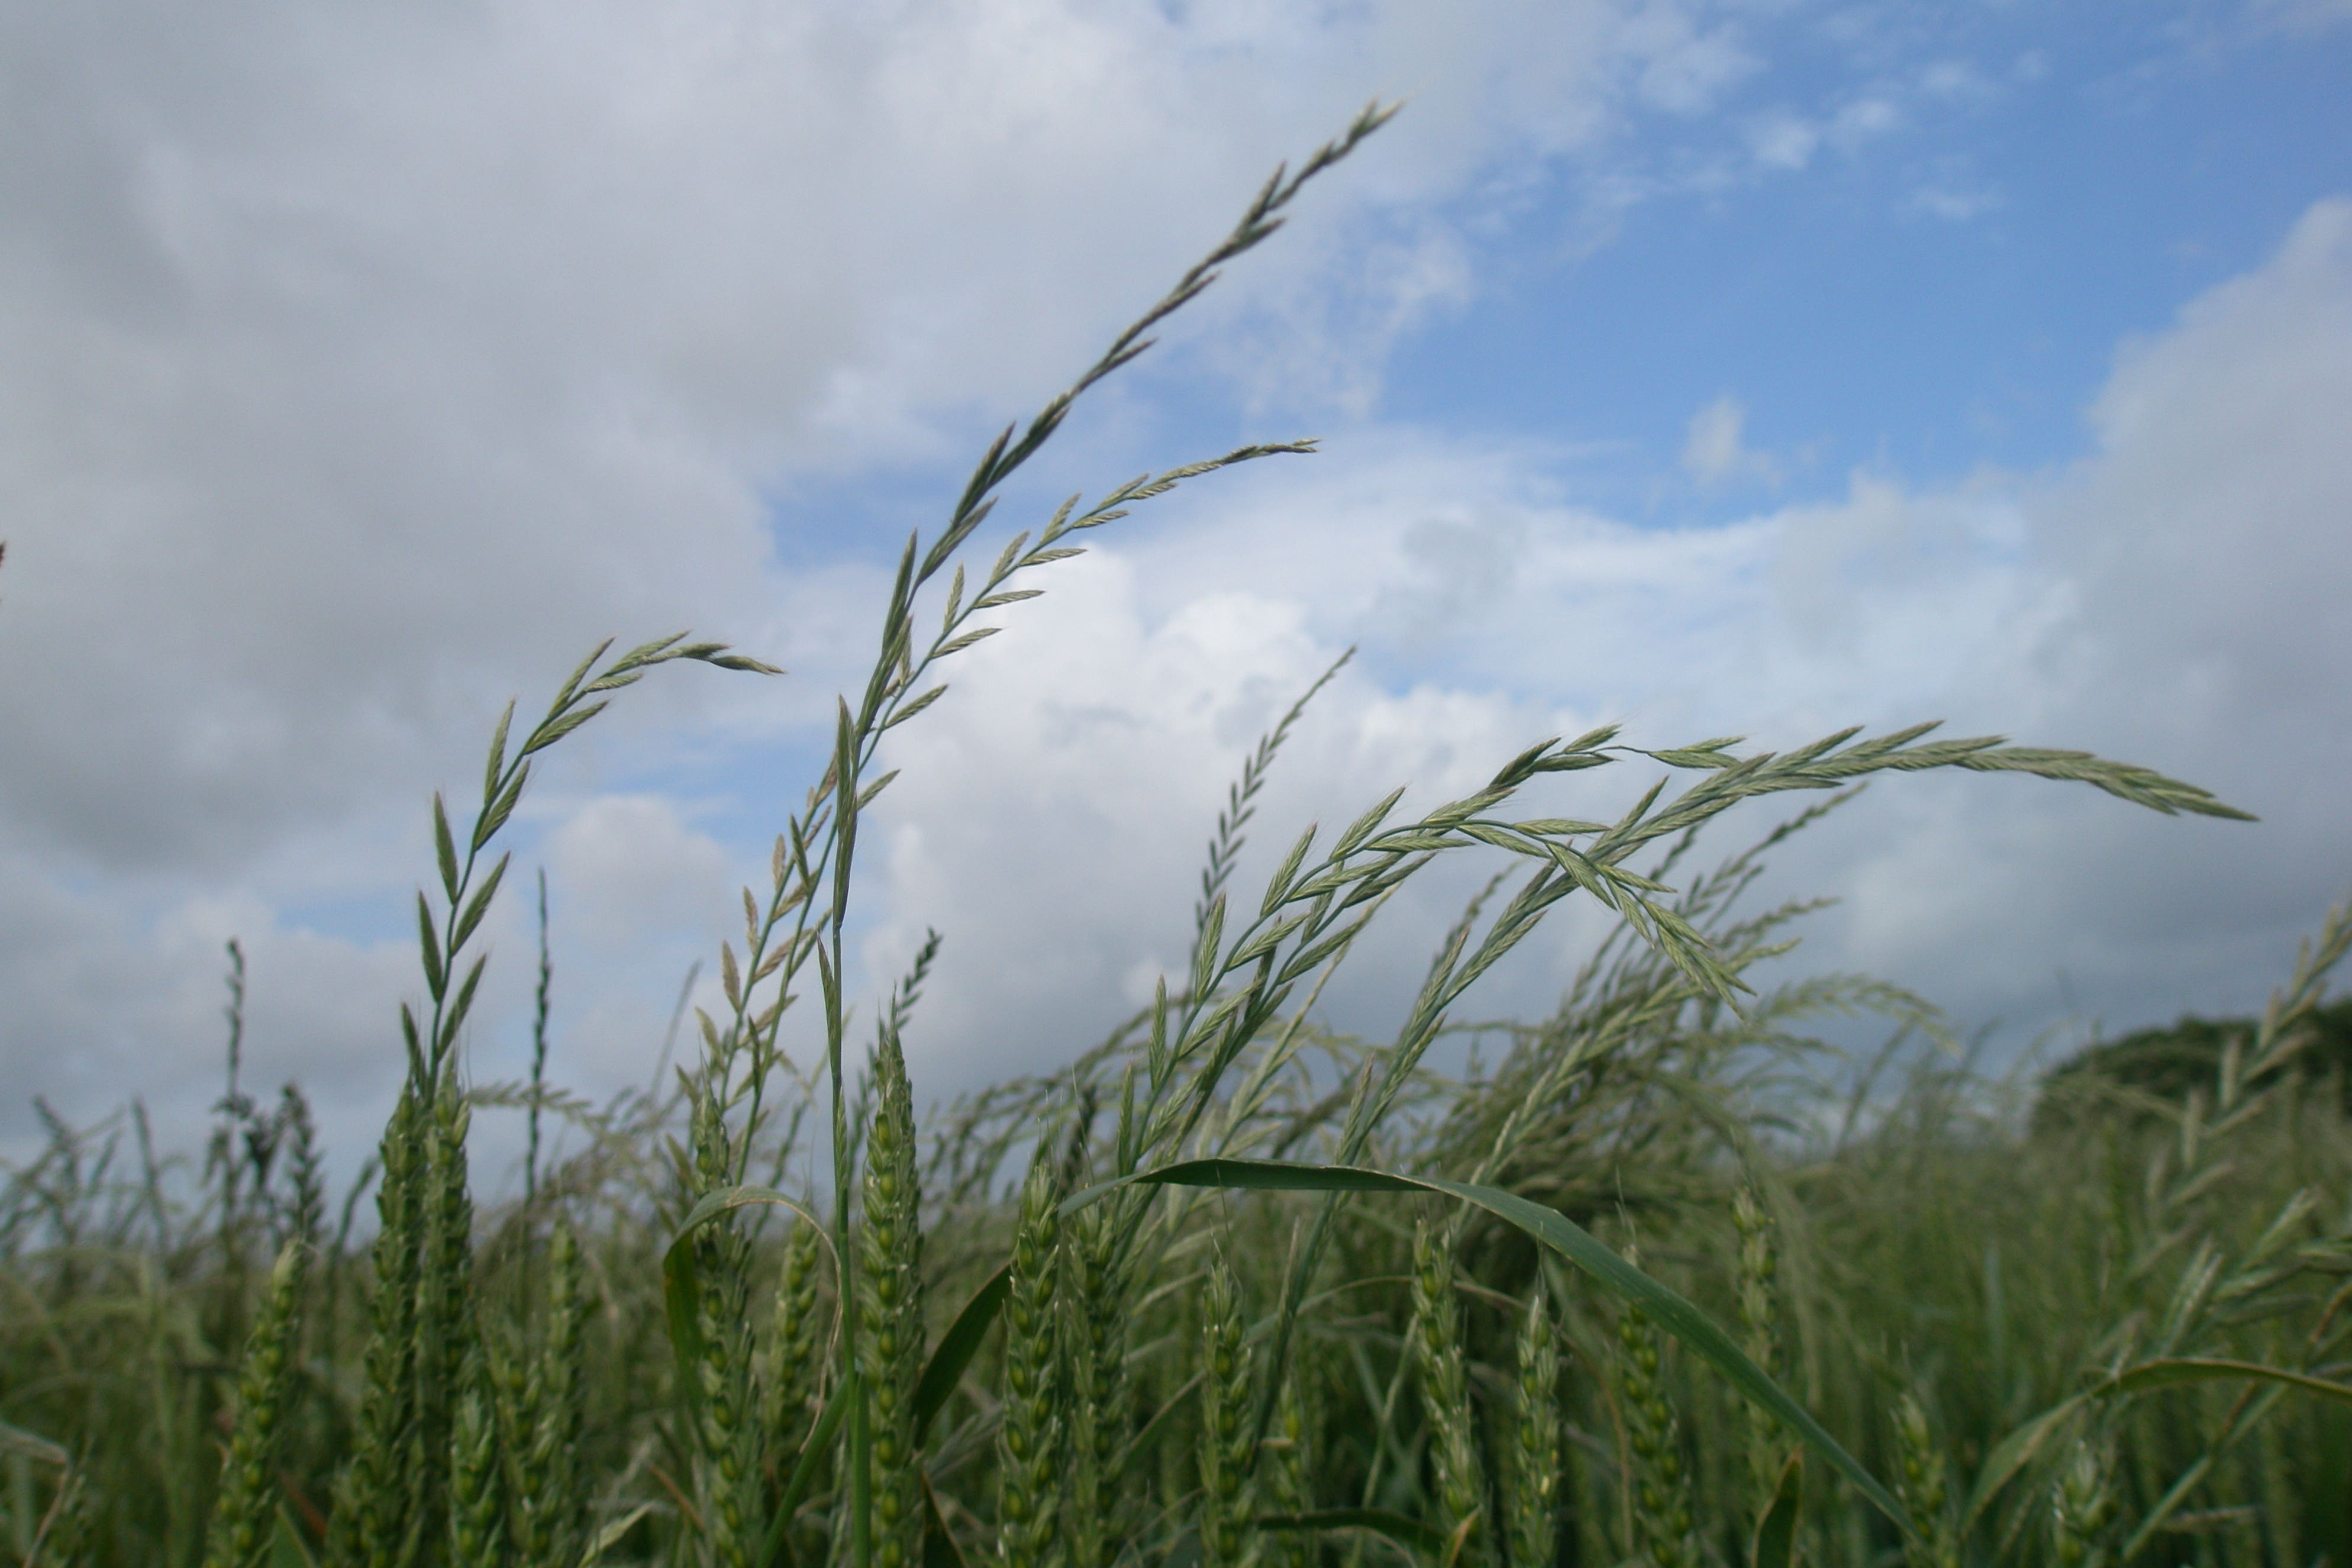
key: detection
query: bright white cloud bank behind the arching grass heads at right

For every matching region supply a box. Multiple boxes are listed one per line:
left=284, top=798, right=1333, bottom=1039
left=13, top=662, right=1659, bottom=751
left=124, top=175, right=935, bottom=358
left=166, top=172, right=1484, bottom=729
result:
left=870, top=202, right=2352, bottom=1082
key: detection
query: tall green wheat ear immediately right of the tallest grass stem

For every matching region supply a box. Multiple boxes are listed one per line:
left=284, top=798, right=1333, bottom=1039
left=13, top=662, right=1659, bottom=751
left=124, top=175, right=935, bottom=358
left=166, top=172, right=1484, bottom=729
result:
left=859, top=1030, right=924, bottom=1568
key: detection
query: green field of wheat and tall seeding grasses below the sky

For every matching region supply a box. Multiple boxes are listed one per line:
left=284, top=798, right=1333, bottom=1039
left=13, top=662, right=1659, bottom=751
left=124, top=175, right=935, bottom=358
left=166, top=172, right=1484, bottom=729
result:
left=0, top=111, right=2352, bottom=1568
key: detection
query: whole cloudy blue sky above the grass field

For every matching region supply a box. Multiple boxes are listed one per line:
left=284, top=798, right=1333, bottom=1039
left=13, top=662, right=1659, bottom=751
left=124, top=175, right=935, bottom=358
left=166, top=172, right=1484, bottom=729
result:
left=0, top=0, right=2352, bottom=1182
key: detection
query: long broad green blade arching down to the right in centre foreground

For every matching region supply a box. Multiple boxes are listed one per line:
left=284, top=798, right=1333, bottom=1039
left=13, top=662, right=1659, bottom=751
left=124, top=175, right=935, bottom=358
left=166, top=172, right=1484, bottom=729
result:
left=1063, top=1159, right=1910, bottom=1537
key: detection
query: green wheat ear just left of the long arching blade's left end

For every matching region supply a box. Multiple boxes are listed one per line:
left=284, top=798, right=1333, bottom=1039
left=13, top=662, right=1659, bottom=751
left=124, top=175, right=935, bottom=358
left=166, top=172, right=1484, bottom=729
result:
left=997, top=1140, right=1063, bottom=1568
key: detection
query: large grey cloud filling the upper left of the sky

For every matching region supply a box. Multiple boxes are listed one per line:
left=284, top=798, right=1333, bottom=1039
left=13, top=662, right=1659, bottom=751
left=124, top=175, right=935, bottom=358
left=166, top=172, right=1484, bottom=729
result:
left=0, top=0, right=1796, bottom=1151
